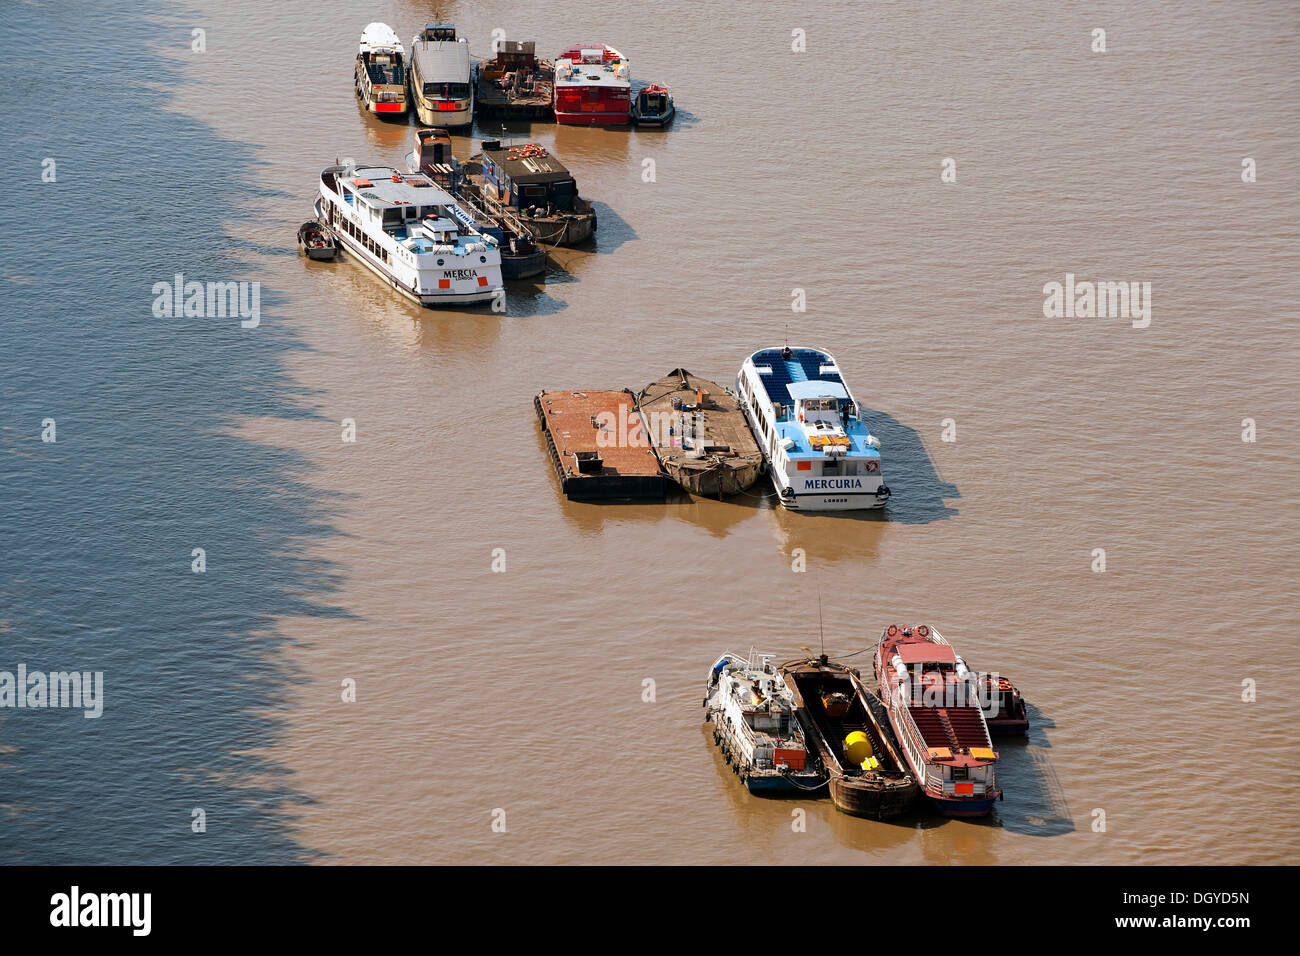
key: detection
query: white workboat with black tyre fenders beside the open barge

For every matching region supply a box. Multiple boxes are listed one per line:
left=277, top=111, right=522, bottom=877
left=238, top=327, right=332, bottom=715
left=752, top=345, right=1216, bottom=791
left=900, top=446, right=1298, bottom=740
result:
left=703, top=654, right=826, bottom=795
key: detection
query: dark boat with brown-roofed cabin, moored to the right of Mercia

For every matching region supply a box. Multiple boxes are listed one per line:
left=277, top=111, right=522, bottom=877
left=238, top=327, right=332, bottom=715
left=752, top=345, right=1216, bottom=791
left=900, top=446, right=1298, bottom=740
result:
left=465, top=139, right=595, bottom=246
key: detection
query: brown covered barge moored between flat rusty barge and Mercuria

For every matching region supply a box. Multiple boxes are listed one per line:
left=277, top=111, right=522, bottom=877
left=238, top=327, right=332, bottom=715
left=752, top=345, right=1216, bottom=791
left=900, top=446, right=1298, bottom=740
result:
left=637, top=368, right=763, bottom=498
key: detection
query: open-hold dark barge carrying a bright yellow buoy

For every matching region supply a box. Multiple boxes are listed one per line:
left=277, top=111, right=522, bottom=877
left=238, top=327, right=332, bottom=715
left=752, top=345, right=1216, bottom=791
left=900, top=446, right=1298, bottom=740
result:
left=781, top=654, right=917, bottom=819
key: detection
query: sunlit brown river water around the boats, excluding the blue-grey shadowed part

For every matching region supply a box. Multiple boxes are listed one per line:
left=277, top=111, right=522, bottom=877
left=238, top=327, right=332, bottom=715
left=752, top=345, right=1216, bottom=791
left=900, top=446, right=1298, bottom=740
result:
left=169, top=0, right=1300, bottom=864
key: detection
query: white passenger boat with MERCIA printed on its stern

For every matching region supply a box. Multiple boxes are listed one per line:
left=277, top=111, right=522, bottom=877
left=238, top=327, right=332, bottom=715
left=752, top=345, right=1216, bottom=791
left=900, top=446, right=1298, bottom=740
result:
left=316, top=165, right=504, bottom=306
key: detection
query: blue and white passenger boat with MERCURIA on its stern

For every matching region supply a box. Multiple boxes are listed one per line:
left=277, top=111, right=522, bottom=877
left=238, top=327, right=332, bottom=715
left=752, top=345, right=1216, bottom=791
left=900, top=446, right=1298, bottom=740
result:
left=736, top=346, right=889, bottom=511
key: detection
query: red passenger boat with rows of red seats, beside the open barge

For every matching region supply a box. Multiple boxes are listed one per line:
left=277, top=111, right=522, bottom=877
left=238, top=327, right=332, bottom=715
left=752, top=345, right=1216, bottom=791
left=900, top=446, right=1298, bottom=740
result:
left=875, top=624, right=1001, bottom=817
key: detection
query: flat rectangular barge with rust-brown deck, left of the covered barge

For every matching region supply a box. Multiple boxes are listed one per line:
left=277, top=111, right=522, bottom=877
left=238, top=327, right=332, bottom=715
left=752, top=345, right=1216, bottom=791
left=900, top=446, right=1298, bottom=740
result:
left=533, top=389, right=670, bottom=501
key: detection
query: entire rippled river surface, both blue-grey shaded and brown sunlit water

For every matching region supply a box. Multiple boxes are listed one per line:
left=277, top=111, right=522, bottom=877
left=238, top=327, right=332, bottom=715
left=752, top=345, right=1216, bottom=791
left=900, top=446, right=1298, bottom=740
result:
left=0, top=0, right=1300, bottom=864
